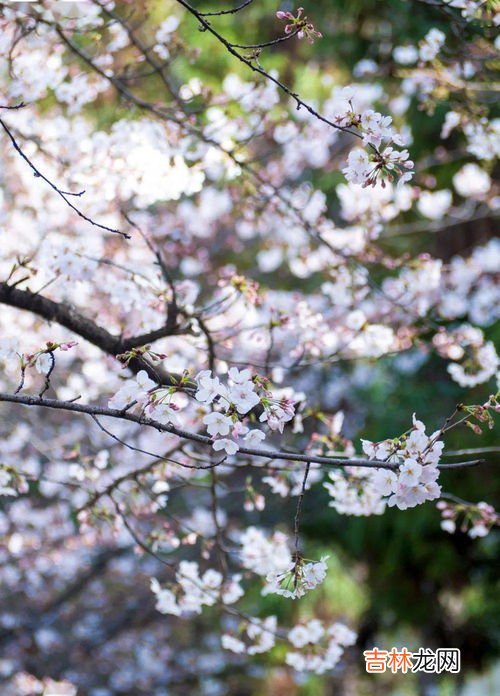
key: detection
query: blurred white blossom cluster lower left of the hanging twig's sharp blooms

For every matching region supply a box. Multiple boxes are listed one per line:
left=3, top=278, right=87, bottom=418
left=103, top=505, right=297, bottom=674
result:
left=151, top=561, right=244, bottom=616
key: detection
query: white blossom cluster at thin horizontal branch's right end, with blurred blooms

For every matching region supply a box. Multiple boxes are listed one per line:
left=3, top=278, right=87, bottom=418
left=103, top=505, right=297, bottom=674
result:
left=324, top=415, right=444, bottom=515
